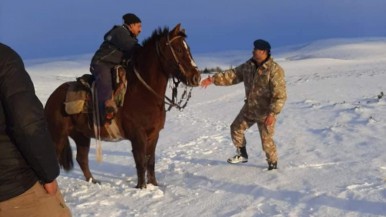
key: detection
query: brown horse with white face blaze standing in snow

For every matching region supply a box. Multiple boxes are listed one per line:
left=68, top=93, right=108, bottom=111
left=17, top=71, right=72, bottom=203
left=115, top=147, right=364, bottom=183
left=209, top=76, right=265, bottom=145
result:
left=45, top=24, right=200, bottom=188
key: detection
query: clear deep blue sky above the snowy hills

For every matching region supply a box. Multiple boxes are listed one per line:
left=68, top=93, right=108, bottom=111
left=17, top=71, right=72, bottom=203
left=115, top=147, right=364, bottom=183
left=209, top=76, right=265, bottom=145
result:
left=0, top=0, right=386, bottom=58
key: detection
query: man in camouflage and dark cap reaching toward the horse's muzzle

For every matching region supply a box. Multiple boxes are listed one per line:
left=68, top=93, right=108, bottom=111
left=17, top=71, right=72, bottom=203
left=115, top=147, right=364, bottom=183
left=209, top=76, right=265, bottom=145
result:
left=201, top=39, right=287, bottom=170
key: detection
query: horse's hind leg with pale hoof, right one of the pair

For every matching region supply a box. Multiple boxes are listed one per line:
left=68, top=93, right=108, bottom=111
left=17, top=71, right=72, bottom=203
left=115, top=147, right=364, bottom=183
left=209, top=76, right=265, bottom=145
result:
left=71, top=133, right=100, bottom=184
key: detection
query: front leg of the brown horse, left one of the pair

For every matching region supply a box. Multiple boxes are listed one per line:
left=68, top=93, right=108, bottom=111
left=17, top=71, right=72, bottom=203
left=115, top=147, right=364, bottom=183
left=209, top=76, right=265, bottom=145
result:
left=132, top=133, right=147, bottom=188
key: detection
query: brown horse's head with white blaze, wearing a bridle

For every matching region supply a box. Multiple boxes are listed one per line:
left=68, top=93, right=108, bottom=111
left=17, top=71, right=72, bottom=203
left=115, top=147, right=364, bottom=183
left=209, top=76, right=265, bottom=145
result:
left=159, top=24, right=201, bottom=86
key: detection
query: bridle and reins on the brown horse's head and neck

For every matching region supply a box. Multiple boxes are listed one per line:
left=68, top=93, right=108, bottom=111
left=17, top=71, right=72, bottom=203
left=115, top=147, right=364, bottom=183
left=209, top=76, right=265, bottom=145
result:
left=134, top=31, right=193, bottom=111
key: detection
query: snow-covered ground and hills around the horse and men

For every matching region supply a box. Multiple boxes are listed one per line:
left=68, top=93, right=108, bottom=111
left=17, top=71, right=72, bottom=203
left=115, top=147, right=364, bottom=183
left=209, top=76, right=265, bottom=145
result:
left=26, top=38, right=386, bottom=217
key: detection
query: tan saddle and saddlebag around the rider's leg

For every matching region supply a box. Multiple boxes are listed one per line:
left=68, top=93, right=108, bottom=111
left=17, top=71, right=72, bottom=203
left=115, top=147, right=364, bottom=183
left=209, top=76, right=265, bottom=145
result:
left=64, top=65, right=127, bottom=115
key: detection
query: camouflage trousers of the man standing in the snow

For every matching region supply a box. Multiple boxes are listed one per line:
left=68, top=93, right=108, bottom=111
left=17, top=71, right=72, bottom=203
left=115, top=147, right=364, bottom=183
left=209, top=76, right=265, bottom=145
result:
left=231, top=111, right=277, bottom=163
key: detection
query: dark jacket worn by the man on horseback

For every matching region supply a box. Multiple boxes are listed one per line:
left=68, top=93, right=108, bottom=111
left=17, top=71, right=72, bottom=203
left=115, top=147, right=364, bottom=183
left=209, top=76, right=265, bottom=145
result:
left=91, top=25, right=139, bottom=66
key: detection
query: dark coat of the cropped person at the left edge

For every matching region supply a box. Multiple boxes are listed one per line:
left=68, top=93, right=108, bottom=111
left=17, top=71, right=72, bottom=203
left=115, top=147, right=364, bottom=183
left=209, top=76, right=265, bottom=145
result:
left=0, top=43, right=59, bottom=201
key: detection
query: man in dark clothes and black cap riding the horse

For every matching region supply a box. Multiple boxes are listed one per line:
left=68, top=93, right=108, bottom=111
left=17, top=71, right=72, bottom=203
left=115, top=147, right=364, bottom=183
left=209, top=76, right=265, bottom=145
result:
left=90, top=13, right=142, bottom=125
